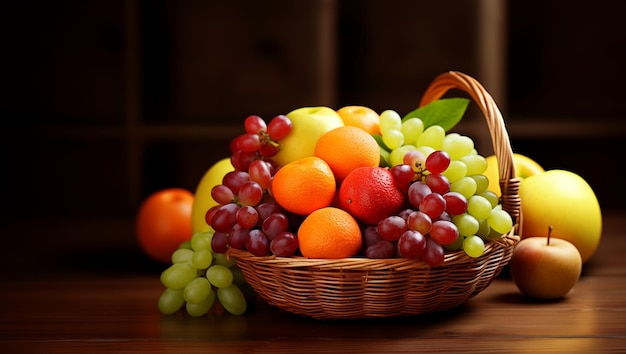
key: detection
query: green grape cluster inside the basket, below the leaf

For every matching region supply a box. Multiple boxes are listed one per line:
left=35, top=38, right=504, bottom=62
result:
left=379, top=110, right=513, bottom=257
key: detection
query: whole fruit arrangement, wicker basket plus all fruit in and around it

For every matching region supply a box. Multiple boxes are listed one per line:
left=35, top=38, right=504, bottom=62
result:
left=149, top=72, right=601, bottom=319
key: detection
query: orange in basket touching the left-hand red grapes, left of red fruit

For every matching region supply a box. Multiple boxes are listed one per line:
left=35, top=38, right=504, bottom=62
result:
left=271, top=156, right=337, bottom=215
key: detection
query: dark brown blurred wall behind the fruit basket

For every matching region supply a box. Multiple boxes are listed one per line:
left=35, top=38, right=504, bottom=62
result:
left=0, top=0, right=626, bottom=266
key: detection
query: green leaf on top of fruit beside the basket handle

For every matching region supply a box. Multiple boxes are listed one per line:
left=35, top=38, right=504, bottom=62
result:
left=402, top=97, right=470, bottom=131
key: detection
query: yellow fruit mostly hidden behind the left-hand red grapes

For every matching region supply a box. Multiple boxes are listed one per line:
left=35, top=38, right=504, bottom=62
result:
left=191, top=158, right=235, bottom=233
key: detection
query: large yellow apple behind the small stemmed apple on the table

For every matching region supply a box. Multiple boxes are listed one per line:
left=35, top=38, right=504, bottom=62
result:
left=519, top=170, right=602, bottom=264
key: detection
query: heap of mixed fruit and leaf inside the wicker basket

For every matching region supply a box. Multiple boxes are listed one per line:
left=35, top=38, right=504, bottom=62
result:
left=205, top=98, right=513, bottom=266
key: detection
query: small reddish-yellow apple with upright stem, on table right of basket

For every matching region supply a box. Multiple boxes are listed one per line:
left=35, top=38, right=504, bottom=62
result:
left=509, top=228, right=582, bottom=299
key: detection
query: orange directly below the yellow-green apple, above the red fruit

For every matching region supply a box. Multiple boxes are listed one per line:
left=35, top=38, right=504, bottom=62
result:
left=314, top=126, right=380, bottom=181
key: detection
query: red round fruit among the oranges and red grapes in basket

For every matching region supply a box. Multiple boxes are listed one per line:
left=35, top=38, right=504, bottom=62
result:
left=339, top=167, right=407, bottom=225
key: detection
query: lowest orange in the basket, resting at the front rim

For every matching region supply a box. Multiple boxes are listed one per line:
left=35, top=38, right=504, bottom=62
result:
left=298, top=207, right=362, bottom=258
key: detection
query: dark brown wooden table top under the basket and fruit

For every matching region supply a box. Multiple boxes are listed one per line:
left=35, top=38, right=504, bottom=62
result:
left=0, top=212, right=626, bottom=353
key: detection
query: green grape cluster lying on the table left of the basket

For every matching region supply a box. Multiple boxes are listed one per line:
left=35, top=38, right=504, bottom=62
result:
left=158, top=231, right=248, bottom=317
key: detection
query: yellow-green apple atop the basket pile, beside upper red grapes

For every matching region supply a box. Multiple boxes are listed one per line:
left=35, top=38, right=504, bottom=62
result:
left=272, top=106, right=344, bottom=166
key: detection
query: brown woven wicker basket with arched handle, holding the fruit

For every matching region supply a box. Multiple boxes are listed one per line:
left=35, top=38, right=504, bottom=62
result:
left=229, top=72, right=521, bottom=319
